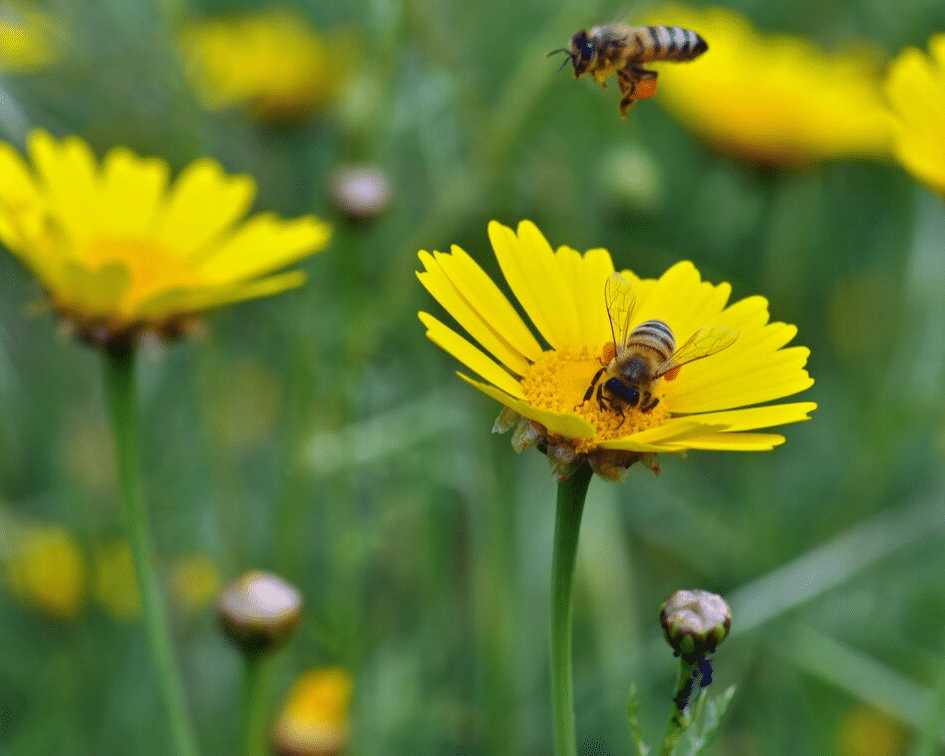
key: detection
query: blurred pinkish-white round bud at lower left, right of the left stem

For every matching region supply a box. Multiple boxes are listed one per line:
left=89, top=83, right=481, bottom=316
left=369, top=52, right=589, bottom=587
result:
left=218, top=571, right=302, bottom=653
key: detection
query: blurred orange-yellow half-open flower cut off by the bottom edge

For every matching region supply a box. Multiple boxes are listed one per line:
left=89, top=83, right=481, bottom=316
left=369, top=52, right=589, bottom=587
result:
left=273, top=667, right=354, bottom=756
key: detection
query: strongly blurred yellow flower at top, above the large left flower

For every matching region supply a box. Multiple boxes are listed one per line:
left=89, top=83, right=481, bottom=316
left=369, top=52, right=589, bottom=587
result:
left=180, top=9, right=356, bottom=120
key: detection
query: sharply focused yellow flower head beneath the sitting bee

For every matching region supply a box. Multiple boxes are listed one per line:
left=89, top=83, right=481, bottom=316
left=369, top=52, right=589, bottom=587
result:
left=417, top=221, right=816, bottom=479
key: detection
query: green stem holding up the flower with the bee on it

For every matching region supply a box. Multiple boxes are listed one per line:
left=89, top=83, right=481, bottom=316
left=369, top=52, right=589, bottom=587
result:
left=551, top=462, right=592, bottom=756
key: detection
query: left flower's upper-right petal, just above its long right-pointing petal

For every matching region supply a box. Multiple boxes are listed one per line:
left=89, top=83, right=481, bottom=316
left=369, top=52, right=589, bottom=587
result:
left=155, top=158, right=256, bottom=258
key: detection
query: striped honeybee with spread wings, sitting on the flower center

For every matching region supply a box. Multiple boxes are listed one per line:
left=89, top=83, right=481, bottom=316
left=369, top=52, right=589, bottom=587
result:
left=581, top=273, right=738, bottom=424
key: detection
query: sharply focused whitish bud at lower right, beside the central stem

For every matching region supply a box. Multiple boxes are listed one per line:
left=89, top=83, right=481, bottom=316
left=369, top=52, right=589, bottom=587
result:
left=660, top=589, right=732, bottom=662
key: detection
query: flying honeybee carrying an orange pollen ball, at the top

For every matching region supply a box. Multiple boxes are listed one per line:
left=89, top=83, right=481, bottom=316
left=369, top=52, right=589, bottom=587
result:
left=548, top=24, right=709, bottom=118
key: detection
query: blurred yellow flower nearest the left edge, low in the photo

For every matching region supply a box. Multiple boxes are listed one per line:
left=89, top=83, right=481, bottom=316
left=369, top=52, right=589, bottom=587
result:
left=6, top=525, right=86, bottom=619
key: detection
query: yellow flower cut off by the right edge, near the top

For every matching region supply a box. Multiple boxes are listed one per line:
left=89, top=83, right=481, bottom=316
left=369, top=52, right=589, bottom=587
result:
left=886, top=34, right=945, bottom=196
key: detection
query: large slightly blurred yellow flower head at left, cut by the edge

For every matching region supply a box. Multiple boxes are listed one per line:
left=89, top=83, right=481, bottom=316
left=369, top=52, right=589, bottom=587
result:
left=0, top=131, right=331, bottom=343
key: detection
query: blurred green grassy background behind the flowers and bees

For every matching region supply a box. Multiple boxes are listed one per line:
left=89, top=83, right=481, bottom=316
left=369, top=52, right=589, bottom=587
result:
left=0, top=0, right=945, bottom=756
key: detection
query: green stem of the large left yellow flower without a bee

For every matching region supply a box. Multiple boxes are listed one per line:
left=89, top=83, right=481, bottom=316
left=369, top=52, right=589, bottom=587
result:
left=105, top=347, right=197, bottom=756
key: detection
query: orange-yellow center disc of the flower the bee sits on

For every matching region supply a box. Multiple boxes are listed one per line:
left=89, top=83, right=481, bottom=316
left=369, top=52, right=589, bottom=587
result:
left=521, top=345, right=669, bottom=453
